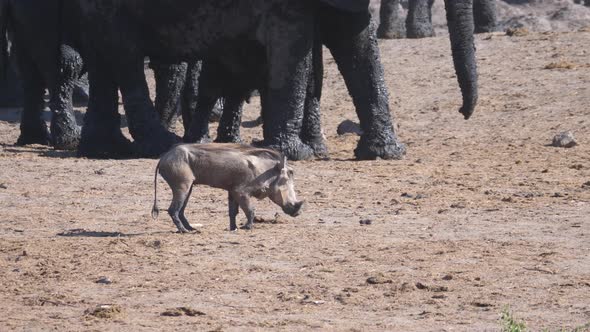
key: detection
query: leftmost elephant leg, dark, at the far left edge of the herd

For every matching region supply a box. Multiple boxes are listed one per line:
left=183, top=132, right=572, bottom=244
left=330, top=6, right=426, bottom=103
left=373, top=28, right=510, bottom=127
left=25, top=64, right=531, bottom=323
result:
left=16, top=46, right=51, bottom=145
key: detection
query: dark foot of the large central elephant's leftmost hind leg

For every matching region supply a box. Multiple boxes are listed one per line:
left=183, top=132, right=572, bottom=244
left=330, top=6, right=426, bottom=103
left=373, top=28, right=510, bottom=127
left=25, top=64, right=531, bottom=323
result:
left=78, top=127, right=134, bottom=159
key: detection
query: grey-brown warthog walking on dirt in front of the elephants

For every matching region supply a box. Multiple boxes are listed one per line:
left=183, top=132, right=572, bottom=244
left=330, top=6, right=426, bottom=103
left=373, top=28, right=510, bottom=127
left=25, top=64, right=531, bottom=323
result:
left=152, top=143, right=303, bottom=233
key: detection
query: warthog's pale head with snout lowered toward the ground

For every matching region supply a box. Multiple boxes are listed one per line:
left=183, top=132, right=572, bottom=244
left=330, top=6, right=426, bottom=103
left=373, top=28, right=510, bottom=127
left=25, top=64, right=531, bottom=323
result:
left=268, top=157, right=303, bottom=217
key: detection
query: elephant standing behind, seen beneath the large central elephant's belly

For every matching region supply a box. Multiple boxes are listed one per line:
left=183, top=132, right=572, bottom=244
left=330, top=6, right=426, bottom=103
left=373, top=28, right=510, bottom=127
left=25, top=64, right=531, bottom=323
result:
left=180, top=34, right=328, bottom=158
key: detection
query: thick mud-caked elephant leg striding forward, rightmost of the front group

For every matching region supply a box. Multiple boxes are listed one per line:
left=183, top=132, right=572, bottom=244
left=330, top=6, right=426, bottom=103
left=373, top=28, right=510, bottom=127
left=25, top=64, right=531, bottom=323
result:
left=322, top=9, right=406, bottom=159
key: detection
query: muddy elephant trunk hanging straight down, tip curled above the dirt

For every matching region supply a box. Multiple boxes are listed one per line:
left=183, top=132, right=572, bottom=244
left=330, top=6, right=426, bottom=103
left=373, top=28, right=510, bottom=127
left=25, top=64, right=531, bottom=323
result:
left=445, top=0, right=477, bottom=120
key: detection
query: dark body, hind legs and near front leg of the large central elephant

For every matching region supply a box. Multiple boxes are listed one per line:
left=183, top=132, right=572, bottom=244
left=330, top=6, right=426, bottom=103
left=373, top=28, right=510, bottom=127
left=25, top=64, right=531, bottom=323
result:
left=72, top=0, right=324, bottom=159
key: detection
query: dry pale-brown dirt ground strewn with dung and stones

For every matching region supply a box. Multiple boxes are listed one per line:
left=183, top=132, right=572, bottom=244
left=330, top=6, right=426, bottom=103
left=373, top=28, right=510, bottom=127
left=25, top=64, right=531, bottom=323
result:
left=0, top=27, right=590, bottom=331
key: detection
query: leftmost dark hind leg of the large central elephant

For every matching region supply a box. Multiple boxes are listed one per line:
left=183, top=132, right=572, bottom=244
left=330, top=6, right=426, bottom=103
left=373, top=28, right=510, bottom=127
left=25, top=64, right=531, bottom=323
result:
left=78, top=56, right=133, bottom=158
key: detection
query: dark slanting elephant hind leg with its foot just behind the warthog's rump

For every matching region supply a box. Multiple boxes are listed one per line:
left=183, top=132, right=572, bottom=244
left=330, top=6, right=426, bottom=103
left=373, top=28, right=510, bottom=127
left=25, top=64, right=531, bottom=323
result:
left=114, top=56, right=179, bottom=157
